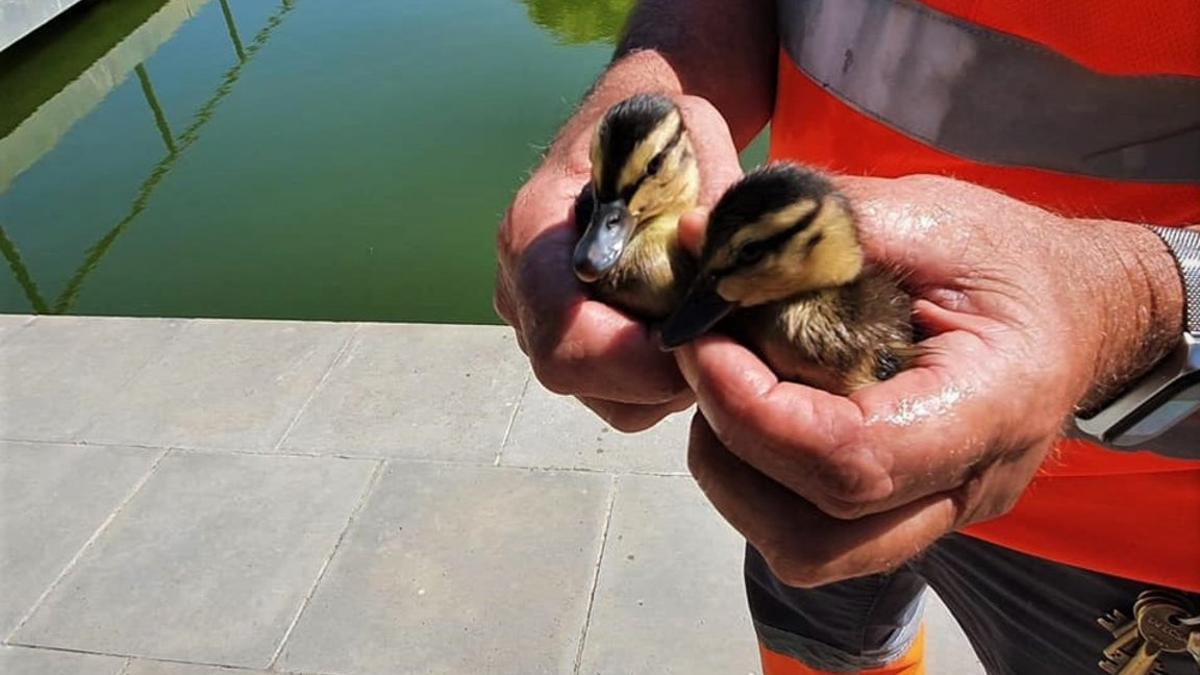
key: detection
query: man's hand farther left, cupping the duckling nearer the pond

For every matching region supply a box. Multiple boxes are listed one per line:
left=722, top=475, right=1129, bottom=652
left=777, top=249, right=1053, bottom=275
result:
left=493, top=91, right=742, bottom=431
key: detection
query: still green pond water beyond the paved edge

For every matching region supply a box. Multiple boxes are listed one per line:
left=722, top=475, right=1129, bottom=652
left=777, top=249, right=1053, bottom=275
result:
left=0, top=0, right=763, bottom=323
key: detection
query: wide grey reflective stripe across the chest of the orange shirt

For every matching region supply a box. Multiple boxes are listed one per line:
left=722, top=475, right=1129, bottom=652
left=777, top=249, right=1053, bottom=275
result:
left=780, top=0, right=1200, bottom=183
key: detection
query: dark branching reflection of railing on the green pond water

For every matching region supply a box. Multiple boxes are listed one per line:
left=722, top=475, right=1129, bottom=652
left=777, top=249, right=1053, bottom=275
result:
left=0, top=0, right=296, bottom=313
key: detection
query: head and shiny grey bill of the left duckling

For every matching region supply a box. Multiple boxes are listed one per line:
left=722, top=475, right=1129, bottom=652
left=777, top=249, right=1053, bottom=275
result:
left=572, top=94, right=700, bottom=282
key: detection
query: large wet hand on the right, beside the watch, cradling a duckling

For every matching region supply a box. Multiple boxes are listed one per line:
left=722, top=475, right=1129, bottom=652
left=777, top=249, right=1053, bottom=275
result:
left=677, top=177, right=1182, bottom=586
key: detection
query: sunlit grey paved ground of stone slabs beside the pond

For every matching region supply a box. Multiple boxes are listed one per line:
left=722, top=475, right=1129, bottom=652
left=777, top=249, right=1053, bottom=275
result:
left=0, top=316, right=982, bottom=675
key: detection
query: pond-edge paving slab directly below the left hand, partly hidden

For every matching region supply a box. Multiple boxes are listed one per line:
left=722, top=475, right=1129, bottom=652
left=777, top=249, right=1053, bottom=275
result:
left=500, top=380, right=692, bottom=473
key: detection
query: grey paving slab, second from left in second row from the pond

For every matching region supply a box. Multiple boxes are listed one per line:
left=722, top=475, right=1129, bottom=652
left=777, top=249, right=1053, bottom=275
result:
left=12, top=453, right=377, bottom=668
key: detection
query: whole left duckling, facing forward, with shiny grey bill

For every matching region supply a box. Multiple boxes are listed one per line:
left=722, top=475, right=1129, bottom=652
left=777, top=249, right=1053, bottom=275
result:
left=572, top=94, right=700, bottom=321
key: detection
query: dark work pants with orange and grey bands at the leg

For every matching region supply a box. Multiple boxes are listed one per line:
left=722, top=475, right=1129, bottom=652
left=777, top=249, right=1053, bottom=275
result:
left=745, top=534, right=1200, bottom=675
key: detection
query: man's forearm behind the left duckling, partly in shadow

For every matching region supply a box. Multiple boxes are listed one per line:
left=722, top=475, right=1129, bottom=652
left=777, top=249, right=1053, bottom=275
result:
left=547, top=0, right=778, bottom=173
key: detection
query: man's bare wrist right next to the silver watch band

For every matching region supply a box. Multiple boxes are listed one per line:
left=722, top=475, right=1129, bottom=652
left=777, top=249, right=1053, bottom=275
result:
left=1079, top=221, right=1184, bottom=411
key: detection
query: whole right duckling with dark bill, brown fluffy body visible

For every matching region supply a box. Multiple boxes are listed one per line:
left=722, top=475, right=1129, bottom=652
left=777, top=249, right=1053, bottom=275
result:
left=662, top=163, right=917, bottom=395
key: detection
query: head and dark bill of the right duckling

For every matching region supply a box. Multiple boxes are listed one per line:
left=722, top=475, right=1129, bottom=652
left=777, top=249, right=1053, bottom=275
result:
left=662, top=163, right=863, bottom=350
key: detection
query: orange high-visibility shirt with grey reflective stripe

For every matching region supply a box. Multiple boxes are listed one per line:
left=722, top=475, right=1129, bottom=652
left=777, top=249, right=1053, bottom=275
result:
left=770, top=0, right=1200, bottom=592
